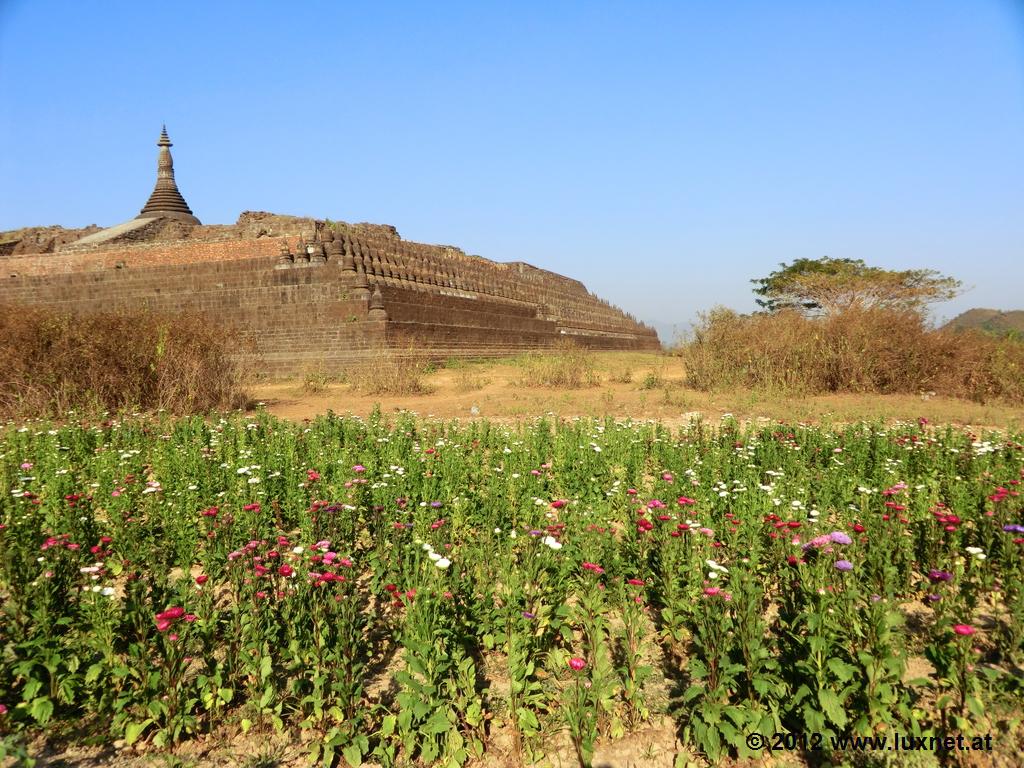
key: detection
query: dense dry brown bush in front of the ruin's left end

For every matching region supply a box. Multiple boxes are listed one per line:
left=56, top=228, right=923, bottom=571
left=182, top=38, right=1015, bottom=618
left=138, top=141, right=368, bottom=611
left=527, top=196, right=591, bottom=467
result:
left=0, top=305, right=248, bottom=418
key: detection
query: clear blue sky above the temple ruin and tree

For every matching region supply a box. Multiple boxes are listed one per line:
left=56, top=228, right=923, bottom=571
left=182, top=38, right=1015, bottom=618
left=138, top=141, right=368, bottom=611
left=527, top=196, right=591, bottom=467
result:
left=0, top=0, right=1024, bottom=338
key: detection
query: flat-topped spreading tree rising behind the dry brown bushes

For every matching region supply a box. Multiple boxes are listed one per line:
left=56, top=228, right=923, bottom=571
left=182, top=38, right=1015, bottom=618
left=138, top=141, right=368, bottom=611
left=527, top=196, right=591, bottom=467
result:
left=751, top=256, right=963, bottom=314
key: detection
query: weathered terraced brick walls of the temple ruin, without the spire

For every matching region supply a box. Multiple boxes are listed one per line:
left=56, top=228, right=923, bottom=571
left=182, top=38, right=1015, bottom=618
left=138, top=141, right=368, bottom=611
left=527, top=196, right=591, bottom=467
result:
left=0, top=230, right=658, bottom=376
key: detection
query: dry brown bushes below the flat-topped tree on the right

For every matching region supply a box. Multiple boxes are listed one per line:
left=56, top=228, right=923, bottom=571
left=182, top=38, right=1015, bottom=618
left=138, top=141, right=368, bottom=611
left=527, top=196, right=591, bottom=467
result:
left=682, top=309, right=1024, bottom=402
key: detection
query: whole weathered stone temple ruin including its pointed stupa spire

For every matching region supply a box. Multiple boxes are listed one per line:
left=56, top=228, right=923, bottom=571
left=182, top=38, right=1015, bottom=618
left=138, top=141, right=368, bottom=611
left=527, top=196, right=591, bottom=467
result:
left=0, top=130, right=659, bottom=376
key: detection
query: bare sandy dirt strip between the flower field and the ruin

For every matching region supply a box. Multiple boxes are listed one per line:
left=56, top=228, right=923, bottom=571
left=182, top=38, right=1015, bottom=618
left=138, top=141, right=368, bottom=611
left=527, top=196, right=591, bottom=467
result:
left=251, top=352, right=1024, bottom=430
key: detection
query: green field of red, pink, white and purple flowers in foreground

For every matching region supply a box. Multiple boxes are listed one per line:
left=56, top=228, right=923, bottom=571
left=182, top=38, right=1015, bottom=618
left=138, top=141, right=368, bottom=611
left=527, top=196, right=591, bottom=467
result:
left=0, top=413, right=1024, bottom=766
